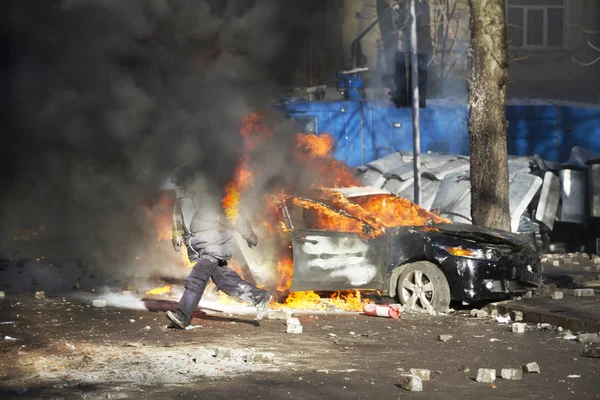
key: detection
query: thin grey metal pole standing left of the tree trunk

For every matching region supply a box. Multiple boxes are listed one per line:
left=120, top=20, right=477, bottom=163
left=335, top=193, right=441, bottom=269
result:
left=410, top=0, right=421, bottom=205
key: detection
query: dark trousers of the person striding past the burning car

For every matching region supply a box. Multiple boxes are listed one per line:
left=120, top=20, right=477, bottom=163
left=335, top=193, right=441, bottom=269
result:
left=178, top=255, right=268, bottom=318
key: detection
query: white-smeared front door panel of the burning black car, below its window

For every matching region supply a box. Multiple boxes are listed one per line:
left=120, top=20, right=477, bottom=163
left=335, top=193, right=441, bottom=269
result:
left=290, top=229, right=384, bottom=291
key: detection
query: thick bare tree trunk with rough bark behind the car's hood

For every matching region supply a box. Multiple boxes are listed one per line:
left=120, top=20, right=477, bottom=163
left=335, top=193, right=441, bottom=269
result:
left=468, top=0, right=510, bottom=231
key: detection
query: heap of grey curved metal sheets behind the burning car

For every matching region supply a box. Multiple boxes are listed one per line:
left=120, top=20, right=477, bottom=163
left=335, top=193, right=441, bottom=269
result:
left=359, top=147, right=600, bottom=244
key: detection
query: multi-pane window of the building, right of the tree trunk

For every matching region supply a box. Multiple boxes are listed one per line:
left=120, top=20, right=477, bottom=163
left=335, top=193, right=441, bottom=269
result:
left=506, top=0, right=566, bottom=49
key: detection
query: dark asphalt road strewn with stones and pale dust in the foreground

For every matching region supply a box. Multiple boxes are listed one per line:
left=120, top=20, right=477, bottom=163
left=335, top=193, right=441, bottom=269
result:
left=0, top=292, right=600, bottom=399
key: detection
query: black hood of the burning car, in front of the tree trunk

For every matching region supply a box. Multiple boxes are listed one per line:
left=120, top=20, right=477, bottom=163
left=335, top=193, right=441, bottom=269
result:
left=432, top=224, right=529, bottom=247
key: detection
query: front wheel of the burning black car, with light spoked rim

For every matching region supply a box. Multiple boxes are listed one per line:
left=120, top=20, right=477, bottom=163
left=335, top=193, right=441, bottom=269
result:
left=396, top=261, right=450, bottom=312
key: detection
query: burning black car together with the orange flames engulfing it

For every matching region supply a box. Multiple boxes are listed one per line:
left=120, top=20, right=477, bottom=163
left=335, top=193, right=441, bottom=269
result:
left=148, top=114, right=541, bottom=311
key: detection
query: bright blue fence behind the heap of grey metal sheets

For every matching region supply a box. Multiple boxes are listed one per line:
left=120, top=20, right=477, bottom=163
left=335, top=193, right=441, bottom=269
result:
left=280, top=100, right=600, bottom=167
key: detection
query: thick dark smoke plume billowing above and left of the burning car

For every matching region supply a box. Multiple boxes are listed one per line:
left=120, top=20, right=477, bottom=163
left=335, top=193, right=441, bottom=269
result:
left=0, top=0, right=328, bottom=282
